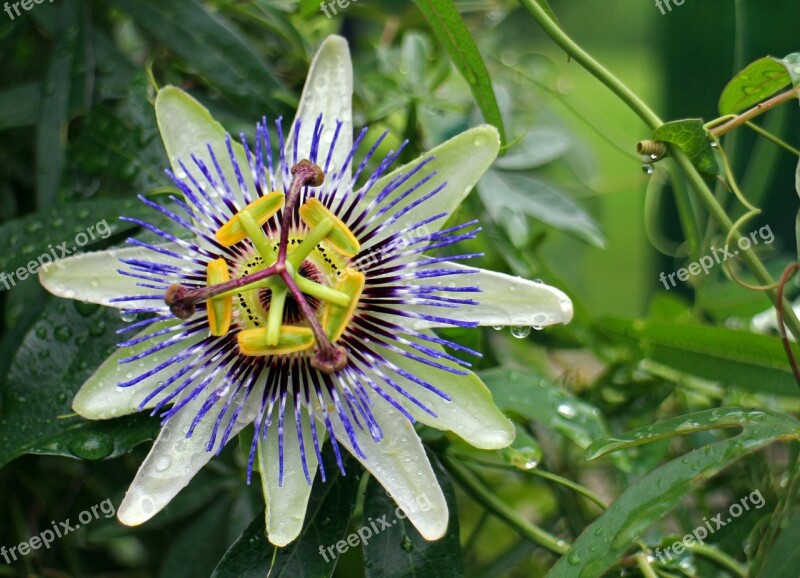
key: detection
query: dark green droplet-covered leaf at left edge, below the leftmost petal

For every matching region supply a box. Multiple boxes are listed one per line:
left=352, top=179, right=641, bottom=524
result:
left=0, top=299, right=123, bottom=466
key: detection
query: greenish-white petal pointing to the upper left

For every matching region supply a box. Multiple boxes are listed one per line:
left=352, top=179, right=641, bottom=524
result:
left=156, top=86, right=255, bottom=207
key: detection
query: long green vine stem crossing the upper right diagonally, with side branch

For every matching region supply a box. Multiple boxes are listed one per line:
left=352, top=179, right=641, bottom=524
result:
left=520, top=0, right=800, bottom=341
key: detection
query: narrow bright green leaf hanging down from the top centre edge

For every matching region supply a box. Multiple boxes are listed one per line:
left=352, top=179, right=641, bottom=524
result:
left=416, top=0, right=506, bottom=144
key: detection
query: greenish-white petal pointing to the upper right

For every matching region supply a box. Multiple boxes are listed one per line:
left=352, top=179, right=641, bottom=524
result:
left=364, top=125, right=500, bottom=248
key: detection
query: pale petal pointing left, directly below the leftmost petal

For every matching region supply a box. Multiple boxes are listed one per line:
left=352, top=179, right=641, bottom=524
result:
left=72, top=320, right=205, bottom=419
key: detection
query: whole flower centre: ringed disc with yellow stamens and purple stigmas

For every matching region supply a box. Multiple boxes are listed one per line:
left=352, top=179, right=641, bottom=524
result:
left=164, top=161, right=365, bottom=373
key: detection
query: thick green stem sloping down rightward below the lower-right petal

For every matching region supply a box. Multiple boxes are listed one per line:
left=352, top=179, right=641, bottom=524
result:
left=443, top=456, right=569, bottom=556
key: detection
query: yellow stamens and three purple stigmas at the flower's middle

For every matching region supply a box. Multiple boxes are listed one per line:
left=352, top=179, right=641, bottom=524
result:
left=164, top=160, right=365, bottom=373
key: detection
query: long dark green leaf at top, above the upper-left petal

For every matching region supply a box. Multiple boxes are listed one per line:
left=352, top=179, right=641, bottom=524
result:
left=111, top=0, right=286, bottom=115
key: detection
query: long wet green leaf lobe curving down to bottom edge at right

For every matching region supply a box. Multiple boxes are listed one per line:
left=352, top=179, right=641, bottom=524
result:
left=547, top=408, right=800, bottom=578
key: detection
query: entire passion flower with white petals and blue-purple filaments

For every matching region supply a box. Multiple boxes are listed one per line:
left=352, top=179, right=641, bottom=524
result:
left=41, top=37, right=572, bottom=545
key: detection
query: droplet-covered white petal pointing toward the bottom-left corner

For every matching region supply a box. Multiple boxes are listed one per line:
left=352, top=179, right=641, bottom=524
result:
left=117, top=384, right=258, bottom=526
